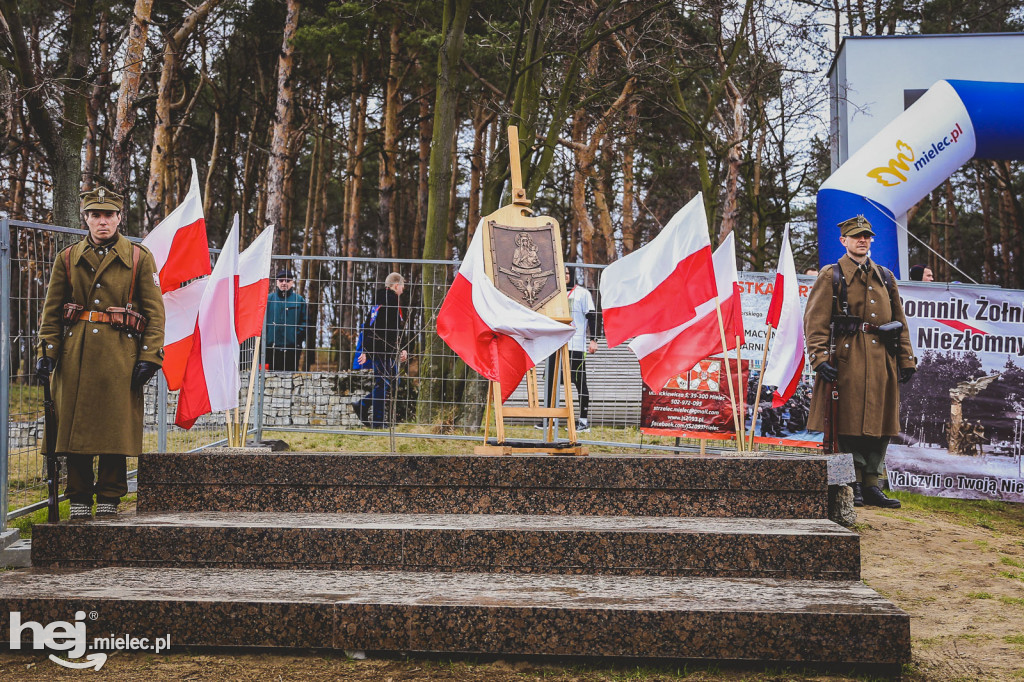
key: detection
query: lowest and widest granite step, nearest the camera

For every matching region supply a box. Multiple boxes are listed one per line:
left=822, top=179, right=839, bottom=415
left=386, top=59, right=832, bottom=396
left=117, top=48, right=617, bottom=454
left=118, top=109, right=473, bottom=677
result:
left=0, top=567, right=910, bottom=667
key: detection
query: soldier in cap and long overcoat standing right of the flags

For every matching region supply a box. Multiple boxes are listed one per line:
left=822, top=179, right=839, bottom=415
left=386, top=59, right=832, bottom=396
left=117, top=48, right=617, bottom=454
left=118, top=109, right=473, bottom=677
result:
left=804, top=215, right=918, bottom=508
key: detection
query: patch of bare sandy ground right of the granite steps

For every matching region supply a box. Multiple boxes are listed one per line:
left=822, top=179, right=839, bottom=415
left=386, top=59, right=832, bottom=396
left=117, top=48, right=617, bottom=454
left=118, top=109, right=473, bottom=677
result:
left=859, top=501, right=1024, bottom=681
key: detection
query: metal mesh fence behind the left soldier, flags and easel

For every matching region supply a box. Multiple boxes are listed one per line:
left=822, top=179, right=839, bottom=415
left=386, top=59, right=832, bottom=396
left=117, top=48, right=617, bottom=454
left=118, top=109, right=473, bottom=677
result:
left=0, top=219, right=696, bottom=516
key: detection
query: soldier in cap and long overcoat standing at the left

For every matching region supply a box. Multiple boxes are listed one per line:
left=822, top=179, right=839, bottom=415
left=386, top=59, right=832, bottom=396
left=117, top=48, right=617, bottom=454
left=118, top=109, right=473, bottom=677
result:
left=36, top=187, right=164, bottom=520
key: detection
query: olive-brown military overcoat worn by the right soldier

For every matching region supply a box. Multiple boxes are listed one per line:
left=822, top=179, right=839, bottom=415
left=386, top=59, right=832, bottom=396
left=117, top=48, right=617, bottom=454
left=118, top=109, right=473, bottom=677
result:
left=804, top=255, right=918, bottom=436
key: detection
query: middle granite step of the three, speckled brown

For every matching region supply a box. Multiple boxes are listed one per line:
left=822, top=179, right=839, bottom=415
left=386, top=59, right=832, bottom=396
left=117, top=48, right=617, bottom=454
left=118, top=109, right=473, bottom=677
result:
left=32, top=512, right=860, bottom=581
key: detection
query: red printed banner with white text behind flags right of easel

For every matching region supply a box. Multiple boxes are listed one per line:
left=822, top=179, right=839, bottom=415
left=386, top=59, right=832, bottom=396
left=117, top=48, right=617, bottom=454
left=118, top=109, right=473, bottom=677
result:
left=640, top=351, right=750, bottom=440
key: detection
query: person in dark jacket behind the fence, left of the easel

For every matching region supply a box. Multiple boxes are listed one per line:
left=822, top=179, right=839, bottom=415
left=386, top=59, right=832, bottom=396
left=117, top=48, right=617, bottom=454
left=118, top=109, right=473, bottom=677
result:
left=355, top=272, right=408, bottom=428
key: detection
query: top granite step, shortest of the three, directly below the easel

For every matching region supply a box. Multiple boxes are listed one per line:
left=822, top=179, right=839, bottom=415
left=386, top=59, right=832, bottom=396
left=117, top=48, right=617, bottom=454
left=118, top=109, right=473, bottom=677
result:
left=138, top=452, right=828, bottom=519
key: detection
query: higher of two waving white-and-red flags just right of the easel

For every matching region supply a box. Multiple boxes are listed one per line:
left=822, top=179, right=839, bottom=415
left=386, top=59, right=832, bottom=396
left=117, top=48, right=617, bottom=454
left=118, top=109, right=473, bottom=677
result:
left=601, top=193, right=715, bottom=348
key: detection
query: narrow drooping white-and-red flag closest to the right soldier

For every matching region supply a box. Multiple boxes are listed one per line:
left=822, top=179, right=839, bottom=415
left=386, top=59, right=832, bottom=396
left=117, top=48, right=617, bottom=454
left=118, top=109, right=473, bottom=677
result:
left=763, top=226, right=804, bottom=408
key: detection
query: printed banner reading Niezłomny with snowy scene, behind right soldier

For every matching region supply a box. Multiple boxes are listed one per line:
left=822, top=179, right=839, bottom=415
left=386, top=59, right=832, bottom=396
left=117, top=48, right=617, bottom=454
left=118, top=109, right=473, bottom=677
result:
left=886, top=283, right=1024, bottom=502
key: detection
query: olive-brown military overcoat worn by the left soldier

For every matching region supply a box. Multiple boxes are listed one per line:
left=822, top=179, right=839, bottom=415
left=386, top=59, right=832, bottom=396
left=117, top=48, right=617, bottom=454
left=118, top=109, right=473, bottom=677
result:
left=37, top=233, right=164, bottom=456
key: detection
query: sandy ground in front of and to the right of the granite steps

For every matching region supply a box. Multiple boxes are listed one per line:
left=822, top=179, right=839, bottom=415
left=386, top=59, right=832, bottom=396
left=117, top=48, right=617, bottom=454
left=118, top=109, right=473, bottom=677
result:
left=0, top=501, right=1024, bottom=682
